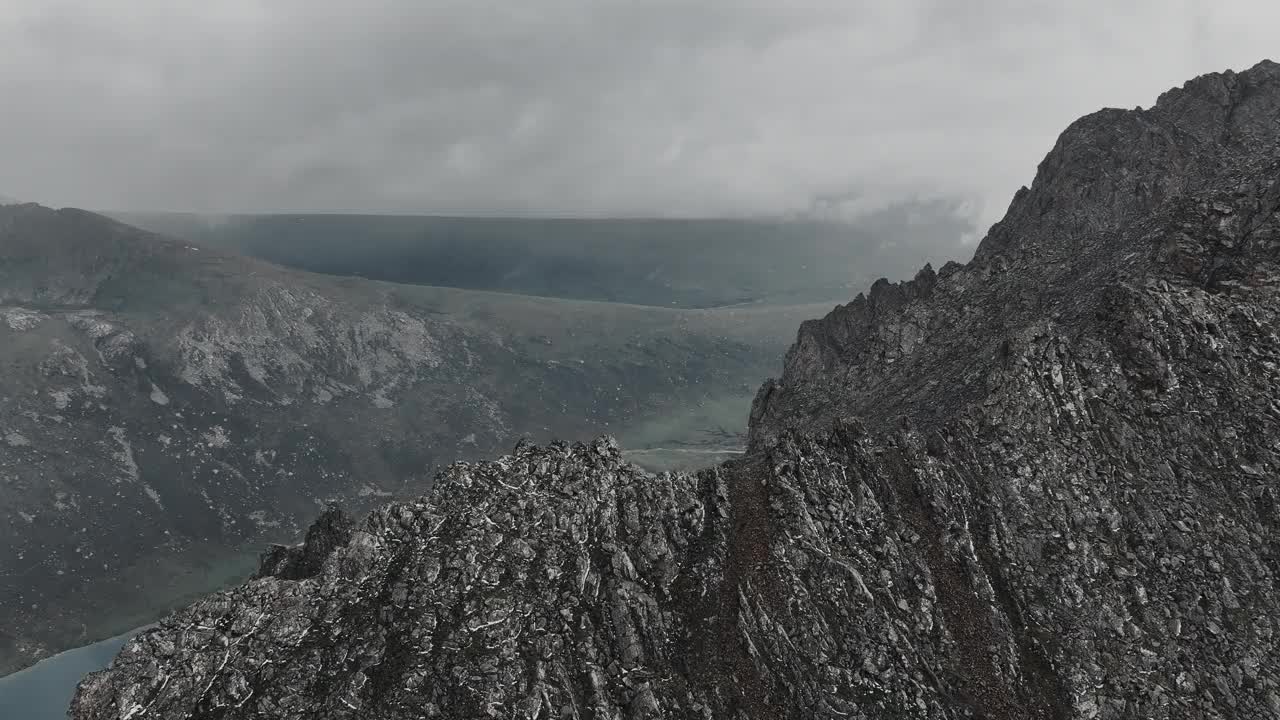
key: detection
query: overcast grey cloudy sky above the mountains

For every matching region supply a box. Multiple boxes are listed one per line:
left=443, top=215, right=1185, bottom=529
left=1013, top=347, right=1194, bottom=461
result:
left=0, top=0, right=1280, bottom=222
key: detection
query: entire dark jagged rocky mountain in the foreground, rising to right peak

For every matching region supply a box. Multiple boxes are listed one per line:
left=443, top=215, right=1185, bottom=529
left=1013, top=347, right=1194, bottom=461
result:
left=72, top=63, right=1280, bottom=720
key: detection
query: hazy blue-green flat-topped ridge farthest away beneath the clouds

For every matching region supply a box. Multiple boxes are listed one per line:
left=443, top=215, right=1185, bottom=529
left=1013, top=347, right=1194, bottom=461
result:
left=114, top=201, right=975, bottom=307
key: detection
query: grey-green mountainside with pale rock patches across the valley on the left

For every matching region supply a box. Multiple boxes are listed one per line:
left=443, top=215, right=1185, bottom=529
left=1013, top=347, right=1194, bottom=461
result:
left=0, top=205, right=813, bottom=671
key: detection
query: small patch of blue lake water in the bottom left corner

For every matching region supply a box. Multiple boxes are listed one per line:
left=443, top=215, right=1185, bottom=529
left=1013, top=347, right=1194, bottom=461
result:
left=0, top=628, right=141, bottom=720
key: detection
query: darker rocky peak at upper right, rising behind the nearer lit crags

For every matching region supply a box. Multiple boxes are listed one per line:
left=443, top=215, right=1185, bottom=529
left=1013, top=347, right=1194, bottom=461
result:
left=751, top=63, right=1280, bottom=443
